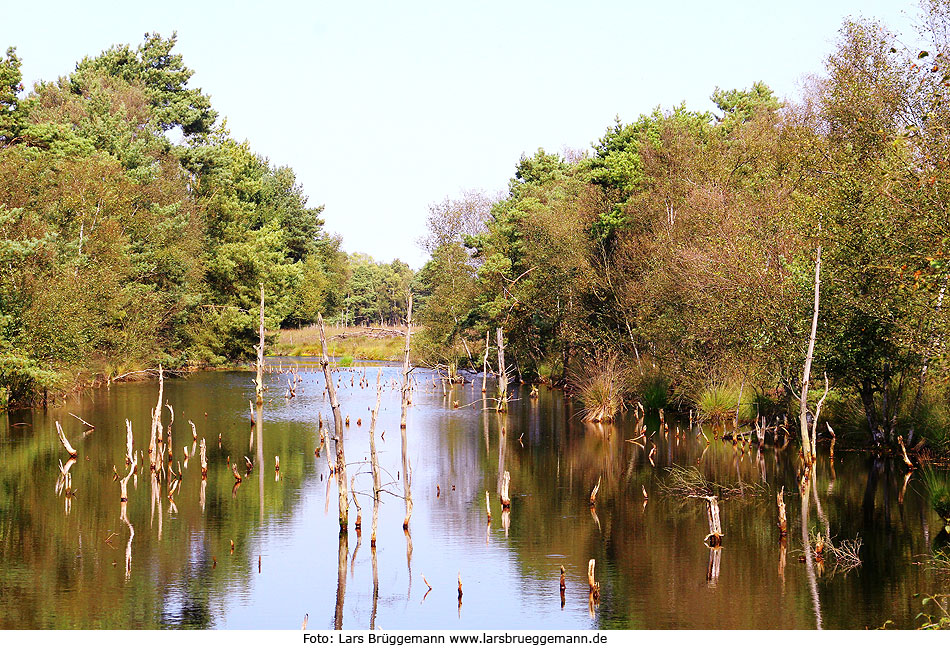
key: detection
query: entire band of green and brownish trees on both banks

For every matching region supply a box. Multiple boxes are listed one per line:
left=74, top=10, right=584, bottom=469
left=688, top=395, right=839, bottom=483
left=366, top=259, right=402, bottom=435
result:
left=0, top=0, right=950, bottom=454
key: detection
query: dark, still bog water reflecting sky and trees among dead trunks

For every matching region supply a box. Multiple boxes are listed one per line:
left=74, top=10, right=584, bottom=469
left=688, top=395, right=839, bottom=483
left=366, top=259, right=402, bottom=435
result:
left=0, top=360, right=950, bottom=630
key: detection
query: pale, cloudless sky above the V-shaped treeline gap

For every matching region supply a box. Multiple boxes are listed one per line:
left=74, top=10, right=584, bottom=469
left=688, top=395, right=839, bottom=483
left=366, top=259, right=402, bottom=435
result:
left=0, top=0, right=917, bottom=268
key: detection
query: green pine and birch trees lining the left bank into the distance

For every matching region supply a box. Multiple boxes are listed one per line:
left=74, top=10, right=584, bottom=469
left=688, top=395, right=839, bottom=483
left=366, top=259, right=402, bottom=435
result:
left=0, top=34, right=412, bottom=408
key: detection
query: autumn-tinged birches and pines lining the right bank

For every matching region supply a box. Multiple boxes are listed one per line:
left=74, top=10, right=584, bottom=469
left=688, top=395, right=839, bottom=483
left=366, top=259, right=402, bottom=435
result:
left=415, top=0, right=950, bottom=454
